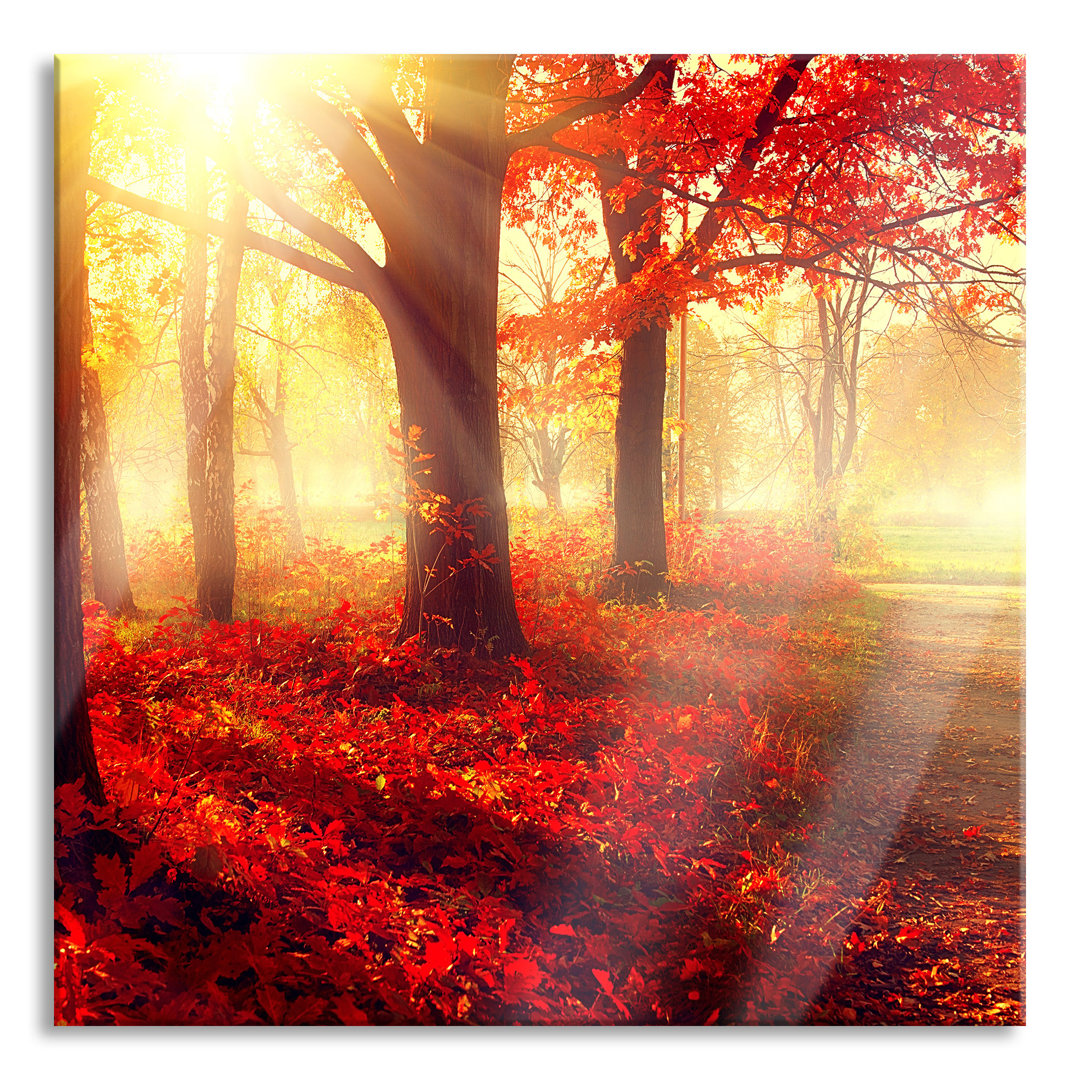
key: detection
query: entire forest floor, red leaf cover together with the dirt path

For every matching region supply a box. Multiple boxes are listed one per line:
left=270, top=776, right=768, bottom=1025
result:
left=54, top=521, right=1025, bottom=1025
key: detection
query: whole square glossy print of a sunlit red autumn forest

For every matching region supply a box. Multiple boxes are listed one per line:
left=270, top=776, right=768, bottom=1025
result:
left=54, top=52, right=1027, bottom=1028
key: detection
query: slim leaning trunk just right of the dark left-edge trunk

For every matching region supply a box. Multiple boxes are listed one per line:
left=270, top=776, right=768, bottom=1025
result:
left=82, top=367, right=136, bottom=616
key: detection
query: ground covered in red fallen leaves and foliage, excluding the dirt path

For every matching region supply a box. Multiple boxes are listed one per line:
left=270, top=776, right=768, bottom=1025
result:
left=55, top=523, right=1019, bottom=1025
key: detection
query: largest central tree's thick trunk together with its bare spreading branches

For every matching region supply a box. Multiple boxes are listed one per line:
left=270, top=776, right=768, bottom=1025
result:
left=86, top=50, right=662, bottom=656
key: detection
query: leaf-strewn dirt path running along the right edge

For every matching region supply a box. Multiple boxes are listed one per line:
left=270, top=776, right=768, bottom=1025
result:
left=730, top=585, right=1025, bottom=1024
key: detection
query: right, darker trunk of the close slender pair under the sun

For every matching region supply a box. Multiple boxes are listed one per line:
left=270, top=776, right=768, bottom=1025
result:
left=197, top=190, right=247, bottom=622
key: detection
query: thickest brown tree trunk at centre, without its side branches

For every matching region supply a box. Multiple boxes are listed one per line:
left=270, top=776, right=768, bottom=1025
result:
left=383, top=56, right=528, bottom=656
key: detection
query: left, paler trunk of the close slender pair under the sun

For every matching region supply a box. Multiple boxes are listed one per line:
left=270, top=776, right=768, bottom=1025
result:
left=179, top=143, right=210, bottom=588
